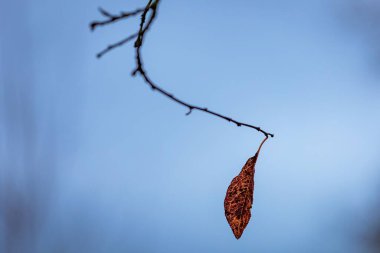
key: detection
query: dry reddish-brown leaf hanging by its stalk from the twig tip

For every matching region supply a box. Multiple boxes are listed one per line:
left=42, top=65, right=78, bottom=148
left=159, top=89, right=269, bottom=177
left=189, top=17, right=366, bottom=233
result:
left=224, top=137, right=268, bottom=239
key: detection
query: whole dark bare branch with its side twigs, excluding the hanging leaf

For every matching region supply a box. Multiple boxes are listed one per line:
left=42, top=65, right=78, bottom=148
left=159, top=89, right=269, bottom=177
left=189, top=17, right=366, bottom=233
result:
left=90, top=0, right=274, bottom=137
